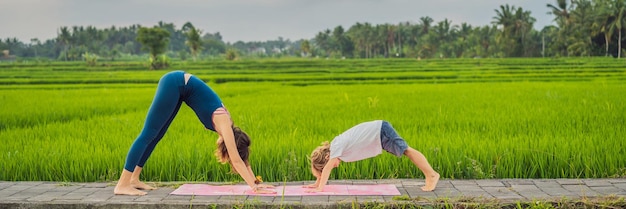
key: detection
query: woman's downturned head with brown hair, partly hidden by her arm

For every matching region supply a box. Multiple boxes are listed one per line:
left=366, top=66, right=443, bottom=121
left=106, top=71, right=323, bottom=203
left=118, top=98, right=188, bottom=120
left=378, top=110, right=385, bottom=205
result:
left=215, top=126, right=251, bottom=170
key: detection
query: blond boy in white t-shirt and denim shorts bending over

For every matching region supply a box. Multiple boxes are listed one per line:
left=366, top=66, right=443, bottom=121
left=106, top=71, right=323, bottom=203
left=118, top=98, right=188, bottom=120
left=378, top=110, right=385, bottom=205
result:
left=304, top=120, right=439, bottom=192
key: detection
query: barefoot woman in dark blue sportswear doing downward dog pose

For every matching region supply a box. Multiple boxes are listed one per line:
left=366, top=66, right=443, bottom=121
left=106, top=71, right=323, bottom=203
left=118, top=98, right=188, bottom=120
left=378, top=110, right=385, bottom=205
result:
left=114, top=71, right=275, bottom=195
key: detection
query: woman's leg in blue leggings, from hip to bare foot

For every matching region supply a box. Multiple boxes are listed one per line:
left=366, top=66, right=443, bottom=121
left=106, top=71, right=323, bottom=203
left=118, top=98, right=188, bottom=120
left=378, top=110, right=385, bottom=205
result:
left=114, top=74, right=182, bottom=195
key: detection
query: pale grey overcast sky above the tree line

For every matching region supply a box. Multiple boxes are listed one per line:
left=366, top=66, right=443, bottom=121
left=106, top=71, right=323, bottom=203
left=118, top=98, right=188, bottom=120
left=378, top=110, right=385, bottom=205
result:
left=0, top=0, right=556, bottom=43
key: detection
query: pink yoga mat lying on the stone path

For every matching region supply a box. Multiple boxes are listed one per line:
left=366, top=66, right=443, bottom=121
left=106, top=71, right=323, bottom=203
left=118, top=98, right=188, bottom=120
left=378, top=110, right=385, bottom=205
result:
left=170, top=184, right=400, bottom=196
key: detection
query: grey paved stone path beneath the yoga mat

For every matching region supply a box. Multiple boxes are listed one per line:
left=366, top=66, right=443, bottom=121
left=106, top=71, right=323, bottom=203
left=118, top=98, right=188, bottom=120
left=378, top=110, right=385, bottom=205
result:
left=0, top=178, right=626, bottom=208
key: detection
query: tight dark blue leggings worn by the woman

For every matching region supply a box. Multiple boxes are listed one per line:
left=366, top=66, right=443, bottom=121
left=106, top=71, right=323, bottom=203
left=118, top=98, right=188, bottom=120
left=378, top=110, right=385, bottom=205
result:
left=124, top=71, right=190, bottom=172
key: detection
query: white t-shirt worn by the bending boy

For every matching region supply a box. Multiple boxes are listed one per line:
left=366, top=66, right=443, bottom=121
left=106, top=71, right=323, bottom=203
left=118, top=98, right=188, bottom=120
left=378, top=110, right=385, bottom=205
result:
left=330, top=120, right=383, bottom=162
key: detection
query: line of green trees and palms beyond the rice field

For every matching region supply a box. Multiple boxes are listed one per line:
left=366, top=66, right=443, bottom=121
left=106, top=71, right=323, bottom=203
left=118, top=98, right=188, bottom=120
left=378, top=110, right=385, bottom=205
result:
left=0, top=0, right=626, bottom=62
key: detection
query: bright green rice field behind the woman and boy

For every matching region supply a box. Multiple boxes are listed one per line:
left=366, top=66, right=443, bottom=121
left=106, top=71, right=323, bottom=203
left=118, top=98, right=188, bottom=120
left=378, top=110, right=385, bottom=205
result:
left=0, top=58, right=626, bottom=182
